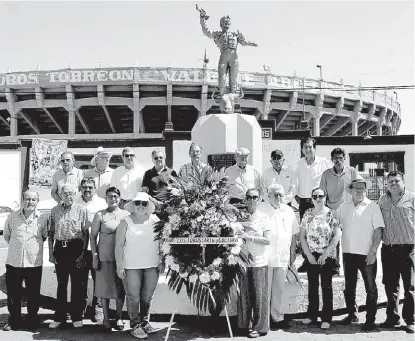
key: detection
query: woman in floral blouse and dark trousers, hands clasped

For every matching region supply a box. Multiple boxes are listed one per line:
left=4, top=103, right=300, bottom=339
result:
left=300, top=188, right=342, bottom=330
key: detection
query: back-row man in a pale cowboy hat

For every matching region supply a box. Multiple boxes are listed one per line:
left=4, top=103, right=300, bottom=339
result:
left=84, top=147, right=114, bottom=199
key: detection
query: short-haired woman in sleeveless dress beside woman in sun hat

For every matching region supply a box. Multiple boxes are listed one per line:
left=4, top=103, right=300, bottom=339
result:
left=90, top=187, right=129, bottom=330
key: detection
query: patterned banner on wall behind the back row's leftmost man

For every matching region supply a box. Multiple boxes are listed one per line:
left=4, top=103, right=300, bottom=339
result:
left=29, top=139, right=68, bottom=188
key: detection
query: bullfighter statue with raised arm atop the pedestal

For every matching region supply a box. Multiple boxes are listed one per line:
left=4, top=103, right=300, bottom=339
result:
left=196, top=5, right=258, bottom=95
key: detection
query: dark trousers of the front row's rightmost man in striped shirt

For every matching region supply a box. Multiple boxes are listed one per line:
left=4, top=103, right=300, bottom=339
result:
left=381, top=244, right=414, bottom=324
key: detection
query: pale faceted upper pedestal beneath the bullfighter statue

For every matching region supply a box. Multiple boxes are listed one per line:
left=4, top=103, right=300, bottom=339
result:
left=192, top=114, right=262, bottom=172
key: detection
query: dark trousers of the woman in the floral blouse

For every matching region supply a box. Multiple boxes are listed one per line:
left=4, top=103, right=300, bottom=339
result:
left=307, top=252, right=336, bottom=323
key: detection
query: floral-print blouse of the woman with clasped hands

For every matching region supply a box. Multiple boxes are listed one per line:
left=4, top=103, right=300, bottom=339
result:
left=301, top=209, right=342, bottom=258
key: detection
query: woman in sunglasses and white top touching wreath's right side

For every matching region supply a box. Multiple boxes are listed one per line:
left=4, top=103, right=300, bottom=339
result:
left=237, top=188, right=271, bottom=338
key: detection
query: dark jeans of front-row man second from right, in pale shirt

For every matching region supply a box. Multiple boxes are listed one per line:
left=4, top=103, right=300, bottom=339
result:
left=343, top=253, right=378, bottom=323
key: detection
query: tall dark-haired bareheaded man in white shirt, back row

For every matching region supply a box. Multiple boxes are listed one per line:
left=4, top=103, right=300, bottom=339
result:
left=293, top=137, right=332, bottom=219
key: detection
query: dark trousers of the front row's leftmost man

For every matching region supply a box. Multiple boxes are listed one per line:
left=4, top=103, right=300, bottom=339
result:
left=6, top=264, right=42, bottom=325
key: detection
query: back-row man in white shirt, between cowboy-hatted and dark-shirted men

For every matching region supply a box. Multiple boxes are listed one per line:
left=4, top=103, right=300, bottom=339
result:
left=110, top=147, right=144, bottom=208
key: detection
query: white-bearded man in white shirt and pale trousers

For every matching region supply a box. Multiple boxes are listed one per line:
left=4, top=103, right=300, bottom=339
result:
left=259, top=184, right=300, bottom=329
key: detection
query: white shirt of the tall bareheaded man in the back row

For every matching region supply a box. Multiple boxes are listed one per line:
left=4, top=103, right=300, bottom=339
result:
left=293, top=155, right=333, bottom=198
